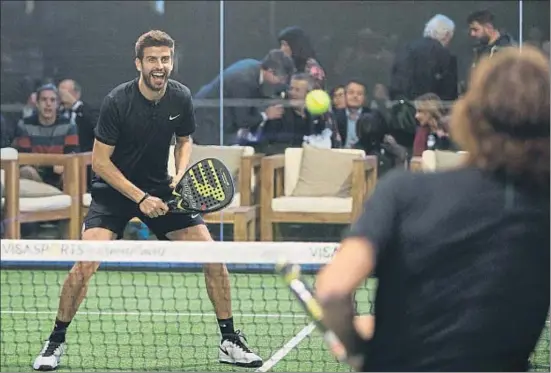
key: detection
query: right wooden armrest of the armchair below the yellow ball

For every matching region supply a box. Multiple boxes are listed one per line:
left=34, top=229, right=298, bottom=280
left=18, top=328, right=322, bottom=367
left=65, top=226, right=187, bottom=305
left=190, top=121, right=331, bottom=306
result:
left=351, top=155, right=378, bottom=220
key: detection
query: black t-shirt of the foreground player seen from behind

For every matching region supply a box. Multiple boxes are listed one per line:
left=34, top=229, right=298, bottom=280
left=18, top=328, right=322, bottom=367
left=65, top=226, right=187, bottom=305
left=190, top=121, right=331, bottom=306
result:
left=349, top=168, right=550, bottom=372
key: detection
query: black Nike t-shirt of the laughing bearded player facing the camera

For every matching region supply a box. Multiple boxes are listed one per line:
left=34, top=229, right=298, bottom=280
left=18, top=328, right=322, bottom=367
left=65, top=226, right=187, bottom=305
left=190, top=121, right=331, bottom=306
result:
left=92, top=79, right=195, bottom=196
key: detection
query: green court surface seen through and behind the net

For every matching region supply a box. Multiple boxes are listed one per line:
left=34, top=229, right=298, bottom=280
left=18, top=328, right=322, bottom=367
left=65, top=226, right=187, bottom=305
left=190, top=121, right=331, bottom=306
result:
left=0, top=270, right=549, bottom=372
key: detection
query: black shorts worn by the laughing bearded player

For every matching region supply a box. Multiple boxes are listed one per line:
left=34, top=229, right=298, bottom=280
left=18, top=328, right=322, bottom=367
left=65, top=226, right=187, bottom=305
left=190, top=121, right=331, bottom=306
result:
left=82, top=191, right=205, bottom=240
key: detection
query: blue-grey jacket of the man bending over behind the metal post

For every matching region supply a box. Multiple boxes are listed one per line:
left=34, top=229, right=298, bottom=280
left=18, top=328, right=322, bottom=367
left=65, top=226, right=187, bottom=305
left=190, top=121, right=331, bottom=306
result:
left=193, top=59, right=263, bottom=145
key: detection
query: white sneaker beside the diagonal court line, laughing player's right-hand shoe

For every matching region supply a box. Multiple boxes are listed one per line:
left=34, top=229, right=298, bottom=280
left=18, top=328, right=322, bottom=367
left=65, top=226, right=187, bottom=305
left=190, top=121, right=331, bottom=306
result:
left=218, top=330, right=262, bottom=368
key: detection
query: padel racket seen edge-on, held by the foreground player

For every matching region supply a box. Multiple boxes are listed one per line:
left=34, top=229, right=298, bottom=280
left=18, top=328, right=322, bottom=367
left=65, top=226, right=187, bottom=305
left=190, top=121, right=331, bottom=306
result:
left=276, top=263, right=363, bottom=371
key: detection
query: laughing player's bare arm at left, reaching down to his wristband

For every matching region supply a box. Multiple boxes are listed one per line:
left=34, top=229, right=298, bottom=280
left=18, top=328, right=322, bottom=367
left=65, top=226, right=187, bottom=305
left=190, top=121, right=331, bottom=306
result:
left=92, top=140, right=145, bottom=203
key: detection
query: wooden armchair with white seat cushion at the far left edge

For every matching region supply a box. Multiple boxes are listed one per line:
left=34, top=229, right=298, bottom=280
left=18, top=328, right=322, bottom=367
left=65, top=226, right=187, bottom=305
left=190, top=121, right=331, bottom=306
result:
left=1, top=148, right=80, bottom=240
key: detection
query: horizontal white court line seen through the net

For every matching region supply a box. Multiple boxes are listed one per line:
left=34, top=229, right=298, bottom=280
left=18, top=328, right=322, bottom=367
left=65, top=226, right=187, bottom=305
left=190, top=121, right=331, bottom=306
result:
left=0, top=310, right=307, bottom=319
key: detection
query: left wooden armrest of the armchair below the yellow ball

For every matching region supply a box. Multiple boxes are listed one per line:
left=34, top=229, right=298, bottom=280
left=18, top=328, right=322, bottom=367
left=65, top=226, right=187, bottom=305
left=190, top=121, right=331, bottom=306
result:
left=260, top=154, right=285, bottom=211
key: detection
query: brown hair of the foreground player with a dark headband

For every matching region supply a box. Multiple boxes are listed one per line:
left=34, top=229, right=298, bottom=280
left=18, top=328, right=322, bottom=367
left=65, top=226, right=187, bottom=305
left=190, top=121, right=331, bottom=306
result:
left=450, top=47, right=550, bottom=193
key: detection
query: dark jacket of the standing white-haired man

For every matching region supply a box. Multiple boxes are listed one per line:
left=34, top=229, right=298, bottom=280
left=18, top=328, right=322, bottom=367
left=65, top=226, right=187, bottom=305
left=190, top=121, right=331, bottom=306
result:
left=389, top=37, right=458, bottom=100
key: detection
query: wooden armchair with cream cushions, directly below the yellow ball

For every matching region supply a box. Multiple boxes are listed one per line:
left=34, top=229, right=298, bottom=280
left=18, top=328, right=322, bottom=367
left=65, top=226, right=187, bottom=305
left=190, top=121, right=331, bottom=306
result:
left=260, top=148, right=377, bottom=241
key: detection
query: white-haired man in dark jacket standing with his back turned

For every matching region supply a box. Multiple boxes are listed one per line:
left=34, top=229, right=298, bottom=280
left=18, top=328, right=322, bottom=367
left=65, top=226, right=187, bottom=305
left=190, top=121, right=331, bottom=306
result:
left=389, top=14, right=458, bottom=153
